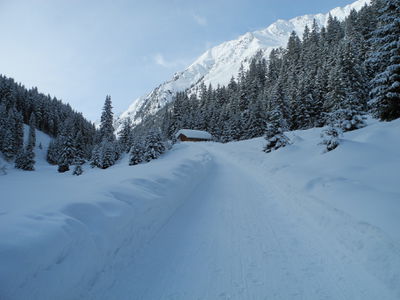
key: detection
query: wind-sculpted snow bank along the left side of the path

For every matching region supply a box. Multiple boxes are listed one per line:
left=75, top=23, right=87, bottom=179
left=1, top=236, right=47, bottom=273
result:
left=0, top=145, right=212, bottom=299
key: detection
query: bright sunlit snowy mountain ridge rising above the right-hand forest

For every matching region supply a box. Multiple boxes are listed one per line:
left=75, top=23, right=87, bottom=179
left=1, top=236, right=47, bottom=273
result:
left=120, top=0, right=370, bottom=123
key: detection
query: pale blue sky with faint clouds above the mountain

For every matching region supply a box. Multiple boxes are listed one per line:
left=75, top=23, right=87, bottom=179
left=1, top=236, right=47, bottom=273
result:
left=0, top=0, right=354, bottom=121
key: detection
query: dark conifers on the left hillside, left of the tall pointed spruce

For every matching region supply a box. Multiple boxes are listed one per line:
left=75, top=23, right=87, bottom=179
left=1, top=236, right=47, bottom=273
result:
left=0, top=76, right=96, bottom=170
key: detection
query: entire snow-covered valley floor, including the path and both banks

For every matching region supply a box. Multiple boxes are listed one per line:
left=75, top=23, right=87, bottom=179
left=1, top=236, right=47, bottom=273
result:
left=0, top=120, right=400, bottom=299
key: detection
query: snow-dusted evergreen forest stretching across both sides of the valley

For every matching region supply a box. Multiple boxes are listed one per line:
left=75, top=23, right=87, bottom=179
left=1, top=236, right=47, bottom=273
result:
left=0, top=0, right=400, bottom=175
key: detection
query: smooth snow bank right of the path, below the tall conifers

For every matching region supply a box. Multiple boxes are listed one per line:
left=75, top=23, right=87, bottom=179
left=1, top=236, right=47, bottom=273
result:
left=206, top=120, right=400, bottom=240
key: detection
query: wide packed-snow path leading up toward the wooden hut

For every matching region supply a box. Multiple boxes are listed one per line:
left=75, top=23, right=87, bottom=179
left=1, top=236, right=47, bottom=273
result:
left=85, top=145, right=400, bottom=299
